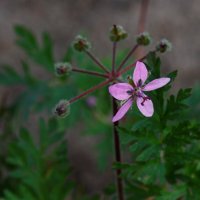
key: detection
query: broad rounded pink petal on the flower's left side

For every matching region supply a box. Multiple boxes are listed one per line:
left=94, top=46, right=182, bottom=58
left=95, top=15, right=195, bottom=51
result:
left=109, top=83, right=133, bottom=100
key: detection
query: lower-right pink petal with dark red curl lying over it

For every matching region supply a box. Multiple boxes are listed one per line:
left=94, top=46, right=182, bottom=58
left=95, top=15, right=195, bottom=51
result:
left=136, top=93, right=154, bottom=117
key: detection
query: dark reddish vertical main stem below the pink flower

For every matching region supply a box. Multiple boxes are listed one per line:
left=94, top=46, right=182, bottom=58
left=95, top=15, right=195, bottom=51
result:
left=112, top=98, right=124, bottom=200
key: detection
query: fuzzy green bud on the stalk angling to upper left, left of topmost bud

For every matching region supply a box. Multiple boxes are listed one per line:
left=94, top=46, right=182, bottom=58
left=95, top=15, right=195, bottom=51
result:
left=73, top=35, right=91, bottom=52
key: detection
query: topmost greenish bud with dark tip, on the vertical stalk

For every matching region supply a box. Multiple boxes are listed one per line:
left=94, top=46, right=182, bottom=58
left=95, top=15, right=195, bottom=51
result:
left=110, top=25, right=128, bottom=42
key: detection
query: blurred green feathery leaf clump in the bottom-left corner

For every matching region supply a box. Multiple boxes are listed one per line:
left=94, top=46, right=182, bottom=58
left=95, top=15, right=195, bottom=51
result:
left=5, top=119, right=73, bottom=200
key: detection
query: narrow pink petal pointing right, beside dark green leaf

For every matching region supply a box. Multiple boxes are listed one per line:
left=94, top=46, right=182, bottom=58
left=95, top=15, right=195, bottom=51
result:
left=143, top=78, right=170, bottom=91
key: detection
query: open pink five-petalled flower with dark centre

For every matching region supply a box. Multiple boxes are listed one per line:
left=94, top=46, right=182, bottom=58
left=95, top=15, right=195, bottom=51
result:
left=109, top=61, right=170, bottom=122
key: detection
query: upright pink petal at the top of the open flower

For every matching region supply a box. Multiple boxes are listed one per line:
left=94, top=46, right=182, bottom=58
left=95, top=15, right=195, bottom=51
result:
left=133, top=61, right=148, bottom=86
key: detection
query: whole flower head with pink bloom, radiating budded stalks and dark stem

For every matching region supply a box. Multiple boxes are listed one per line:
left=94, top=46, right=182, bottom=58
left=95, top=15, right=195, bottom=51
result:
left=54, top=25, right=170, bottom=200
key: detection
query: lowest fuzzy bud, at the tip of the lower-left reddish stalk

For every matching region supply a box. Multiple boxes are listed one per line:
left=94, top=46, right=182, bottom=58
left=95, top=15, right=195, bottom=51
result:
left=53, top=100, right=70, bottom=118
